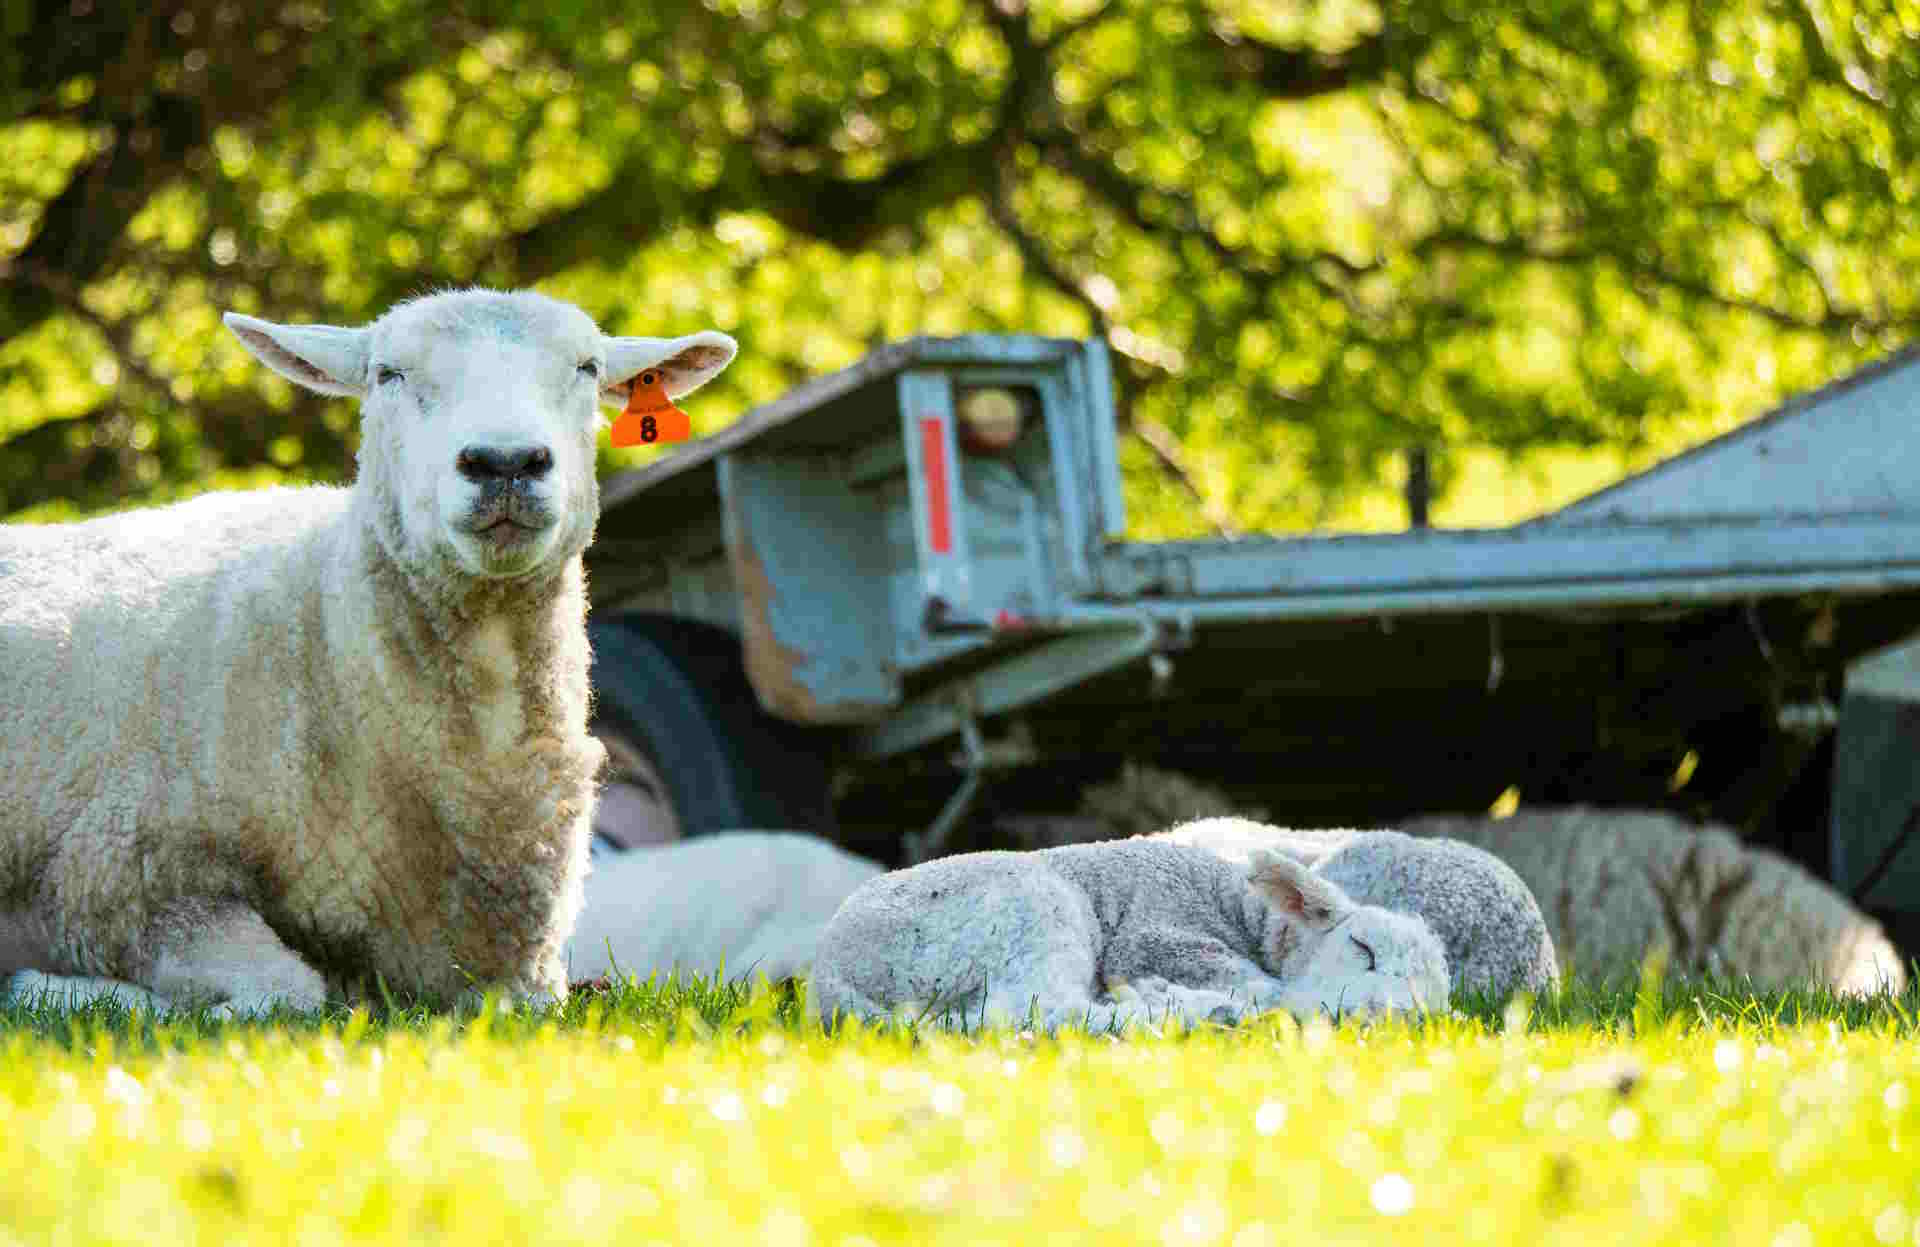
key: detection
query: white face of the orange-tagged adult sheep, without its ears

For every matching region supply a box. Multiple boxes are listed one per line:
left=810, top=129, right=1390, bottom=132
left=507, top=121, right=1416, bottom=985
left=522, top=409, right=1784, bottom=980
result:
left=361, top=294, right=607, bottom=578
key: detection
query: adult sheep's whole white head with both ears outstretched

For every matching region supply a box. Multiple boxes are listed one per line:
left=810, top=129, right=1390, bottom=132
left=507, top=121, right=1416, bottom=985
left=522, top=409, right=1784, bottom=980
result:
left=225, top=290, right=735, bottom=578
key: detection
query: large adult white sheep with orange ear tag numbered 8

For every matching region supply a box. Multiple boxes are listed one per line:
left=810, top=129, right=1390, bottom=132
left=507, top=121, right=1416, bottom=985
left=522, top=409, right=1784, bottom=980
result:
left=0, top=290, right=735, bottom=1009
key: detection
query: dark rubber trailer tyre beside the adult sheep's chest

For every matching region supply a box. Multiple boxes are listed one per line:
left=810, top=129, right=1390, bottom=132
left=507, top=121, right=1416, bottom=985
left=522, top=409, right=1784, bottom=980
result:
left=588, top=611, right=833, bottom=836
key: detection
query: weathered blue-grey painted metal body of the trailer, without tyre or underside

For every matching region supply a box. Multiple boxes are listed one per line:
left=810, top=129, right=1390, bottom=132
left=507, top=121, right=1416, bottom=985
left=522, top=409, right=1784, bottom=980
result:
left=593, top=336, right=1920, bottom=757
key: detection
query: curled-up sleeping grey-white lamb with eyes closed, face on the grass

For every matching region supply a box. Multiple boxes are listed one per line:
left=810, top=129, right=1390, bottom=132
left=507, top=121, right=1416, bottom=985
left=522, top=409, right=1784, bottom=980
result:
left=808, top=840, right=1448, bottom=1030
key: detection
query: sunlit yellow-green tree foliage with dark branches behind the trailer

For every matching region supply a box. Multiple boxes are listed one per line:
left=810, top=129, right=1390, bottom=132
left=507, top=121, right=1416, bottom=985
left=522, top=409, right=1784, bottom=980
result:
left=0, top=0, right=1920, bottom=534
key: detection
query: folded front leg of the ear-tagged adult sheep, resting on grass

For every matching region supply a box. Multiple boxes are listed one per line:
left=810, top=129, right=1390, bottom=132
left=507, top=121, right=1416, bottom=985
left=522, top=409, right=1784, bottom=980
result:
left=146, top=903, right=326, bottom=1016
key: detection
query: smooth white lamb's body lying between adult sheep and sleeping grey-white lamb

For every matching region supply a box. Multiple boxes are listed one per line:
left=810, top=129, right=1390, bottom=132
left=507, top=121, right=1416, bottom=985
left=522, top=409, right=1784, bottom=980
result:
left=568, top=832, right=883, bottom=982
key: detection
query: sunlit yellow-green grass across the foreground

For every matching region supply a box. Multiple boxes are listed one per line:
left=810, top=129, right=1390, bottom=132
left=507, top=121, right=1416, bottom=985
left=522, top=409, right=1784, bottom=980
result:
left=0, top=984, right=1920, bottom=1247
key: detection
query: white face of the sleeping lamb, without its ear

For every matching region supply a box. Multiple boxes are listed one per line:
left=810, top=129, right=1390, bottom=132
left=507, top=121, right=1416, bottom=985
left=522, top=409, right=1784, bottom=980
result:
left=1296, top=905, right=1448, bottom=1013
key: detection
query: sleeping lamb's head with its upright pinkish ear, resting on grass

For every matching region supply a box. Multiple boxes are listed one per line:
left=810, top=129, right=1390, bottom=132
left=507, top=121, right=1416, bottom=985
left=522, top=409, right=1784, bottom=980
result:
left=1248, top=849, right=1450, bottom=1013
